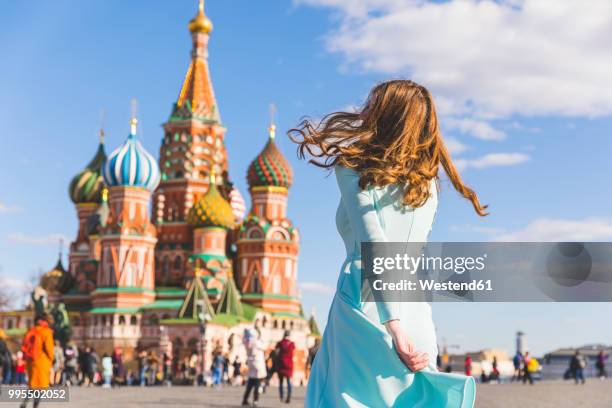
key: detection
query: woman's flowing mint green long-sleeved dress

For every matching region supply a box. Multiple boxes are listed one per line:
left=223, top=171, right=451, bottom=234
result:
left=305, top=166, right=476, bottom=408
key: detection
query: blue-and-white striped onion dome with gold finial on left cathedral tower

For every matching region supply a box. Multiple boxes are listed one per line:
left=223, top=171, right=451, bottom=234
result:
left=103, top=119, right=160, bottom=191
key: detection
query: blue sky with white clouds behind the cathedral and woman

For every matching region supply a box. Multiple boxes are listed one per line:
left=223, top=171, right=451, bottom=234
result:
left=0, top=0, right=612, bottom=353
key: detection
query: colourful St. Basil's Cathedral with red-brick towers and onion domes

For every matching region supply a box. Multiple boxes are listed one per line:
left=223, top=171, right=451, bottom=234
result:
left=2, top=1, right=319, bottom=381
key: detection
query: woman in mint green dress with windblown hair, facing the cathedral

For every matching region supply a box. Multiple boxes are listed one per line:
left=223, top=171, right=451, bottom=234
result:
left=289, top=80, right=486, bottom=408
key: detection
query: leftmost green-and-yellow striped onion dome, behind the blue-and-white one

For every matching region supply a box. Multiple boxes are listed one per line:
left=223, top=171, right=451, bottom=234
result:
left=68, top=130, right=106, bottom=204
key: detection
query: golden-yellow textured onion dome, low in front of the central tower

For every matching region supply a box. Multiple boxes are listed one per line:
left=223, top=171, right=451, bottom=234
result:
left=187, top=174, right=235, bottom=229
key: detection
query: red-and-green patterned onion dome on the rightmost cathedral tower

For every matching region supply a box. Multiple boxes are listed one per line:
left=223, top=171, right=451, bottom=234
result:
left=247, top=125, right=293, bottom=188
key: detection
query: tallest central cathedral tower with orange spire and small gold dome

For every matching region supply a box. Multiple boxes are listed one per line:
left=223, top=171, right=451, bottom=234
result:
left=153, top=0, right=227, bottom=286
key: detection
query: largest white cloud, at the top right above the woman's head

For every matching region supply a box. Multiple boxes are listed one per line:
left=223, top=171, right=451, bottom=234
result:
left=294, top=0, right=612, bottom=118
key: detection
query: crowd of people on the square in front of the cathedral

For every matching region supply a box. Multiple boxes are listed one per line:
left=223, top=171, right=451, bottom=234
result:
left=0, top=314, right=306, bottom=406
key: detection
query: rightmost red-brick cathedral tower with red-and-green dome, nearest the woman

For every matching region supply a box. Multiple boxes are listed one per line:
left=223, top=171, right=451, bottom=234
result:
left=236, top=125, right=300, bottom=316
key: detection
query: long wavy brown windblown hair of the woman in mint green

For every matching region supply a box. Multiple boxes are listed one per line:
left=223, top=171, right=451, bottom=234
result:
left=288, top=80, right=487, bottom=216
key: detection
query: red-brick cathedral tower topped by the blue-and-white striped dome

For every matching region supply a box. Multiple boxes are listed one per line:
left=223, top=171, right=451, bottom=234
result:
left=93, top=118, right=160, bottom=308
